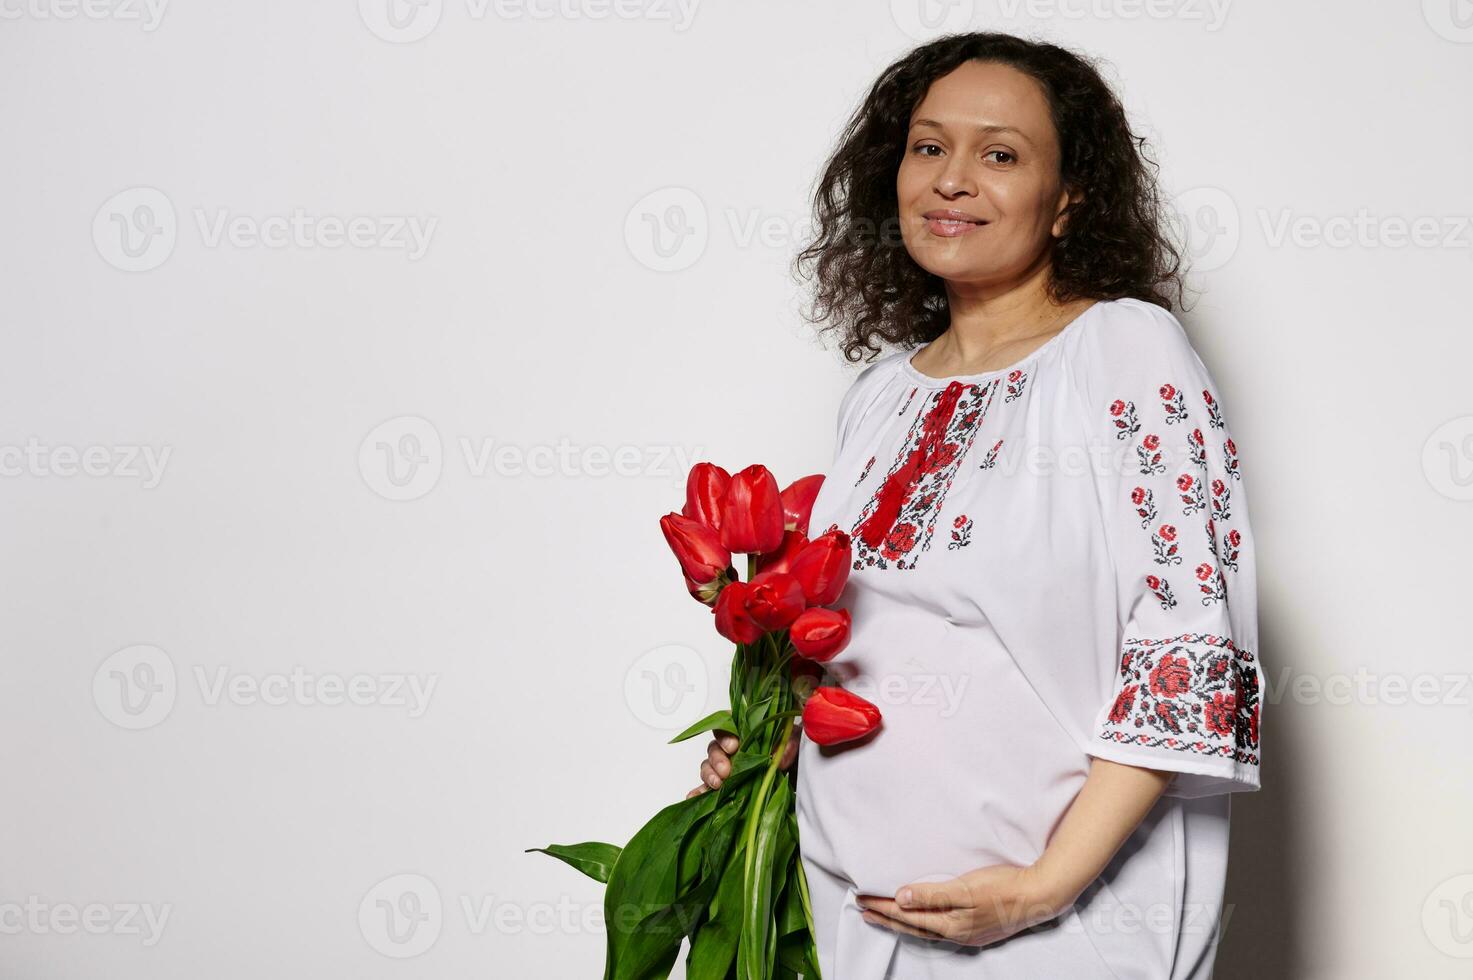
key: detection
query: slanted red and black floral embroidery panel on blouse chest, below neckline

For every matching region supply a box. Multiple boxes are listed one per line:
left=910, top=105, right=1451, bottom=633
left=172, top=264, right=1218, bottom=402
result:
left=850, top=379, right=997, bottom=569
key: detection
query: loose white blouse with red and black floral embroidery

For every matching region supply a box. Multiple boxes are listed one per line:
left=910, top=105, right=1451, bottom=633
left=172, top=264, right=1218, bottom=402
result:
left=797, top=299, right=1262, bottom=980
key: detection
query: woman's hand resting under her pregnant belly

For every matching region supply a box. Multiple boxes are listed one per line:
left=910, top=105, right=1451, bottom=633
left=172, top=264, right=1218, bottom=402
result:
left=854, top=865, right=1069, bottom=946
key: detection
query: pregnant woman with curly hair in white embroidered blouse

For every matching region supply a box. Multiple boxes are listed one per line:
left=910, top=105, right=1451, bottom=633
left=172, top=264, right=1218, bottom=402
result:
left=692, top=34, right=1262, bottom=980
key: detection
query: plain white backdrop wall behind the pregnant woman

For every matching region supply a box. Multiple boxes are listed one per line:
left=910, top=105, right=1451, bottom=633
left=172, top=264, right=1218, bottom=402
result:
left=0, top=0, right=1473, bottom=980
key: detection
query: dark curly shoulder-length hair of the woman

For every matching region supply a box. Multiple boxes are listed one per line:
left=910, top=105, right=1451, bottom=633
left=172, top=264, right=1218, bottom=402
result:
left=794, top=32, right=1183, bottom=361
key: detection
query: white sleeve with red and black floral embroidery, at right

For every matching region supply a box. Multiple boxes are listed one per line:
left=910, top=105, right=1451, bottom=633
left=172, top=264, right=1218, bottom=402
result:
left=1083, top=304, right=1262, bottom=797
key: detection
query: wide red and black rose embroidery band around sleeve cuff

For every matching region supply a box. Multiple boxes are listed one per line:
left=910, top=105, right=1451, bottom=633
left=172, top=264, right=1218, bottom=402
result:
left=1099, top=634, right=1259, bottom=765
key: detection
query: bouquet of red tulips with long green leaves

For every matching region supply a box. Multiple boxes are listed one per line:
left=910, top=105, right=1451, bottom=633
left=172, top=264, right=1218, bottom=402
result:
left=529, top=463, right=879, bottom=980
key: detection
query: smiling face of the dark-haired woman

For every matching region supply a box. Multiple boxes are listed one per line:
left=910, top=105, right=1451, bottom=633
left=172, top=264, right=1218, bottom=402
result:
left=896, top=62, right=1068, bottom=287
